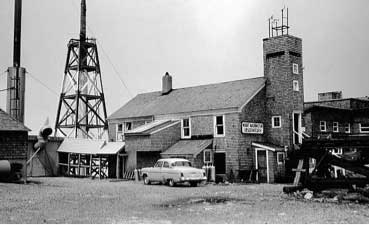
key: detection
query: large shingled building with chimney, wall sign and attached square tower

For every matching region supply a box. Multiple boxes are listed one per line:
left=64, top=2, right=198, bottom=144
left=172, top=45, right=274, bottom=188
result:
left=108, top=35, right=304, bottom=182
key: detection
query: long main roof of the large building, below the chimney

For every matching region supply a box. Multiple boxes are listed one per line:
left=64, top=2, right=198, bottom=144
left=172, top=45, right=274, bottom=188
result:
left=108, top=77, right=265, bottom=119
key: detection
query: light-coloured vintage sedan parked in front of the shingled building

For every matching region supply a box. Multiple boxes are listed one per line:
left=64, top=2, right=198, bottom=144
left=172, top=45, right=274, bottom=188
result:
left=141, top=158, right=206, bottom=187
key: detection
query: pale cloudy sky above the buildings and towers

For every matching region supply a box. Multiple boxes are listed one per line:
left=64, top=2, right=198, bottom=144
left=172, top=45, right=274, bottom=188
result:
left=0, top=0, right=369, bottom=134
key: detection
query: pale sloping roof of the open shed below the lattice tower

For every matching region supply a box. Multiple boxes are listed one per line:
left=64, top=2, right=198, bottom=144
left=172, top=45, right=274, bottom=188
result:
left=57, top=138, right=124, bottom=155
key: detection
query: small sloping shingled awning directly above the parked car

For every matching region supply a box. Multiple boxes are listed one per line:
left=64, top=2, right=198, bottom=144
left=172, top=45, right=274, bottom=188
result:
left=160, top=139, right=213, bottom=156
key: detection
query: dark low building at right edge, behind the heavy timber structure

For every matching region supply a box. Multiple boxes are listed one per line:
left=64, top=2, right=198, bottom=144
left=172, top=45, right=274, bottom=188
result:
left=304, top=92, right=369, bottom=177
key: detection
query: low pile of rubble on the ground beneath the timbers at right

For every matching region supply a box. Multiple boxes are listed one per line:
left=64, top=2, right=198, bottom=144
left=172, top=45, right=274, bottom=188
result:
left=284, top=186, right=369, bottom=203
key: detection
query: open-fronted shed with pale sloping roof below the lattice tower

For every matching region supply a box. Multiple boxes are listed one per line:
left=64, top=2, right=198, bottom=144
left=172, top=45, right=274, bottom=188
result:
left=58, top=138, right=126, bottom=178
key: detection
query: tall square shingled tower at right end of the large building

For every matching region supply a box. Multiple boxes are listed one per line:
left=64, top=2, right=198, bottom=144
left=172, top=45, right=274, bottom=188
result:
left=263, top=34, right=304, bottom=149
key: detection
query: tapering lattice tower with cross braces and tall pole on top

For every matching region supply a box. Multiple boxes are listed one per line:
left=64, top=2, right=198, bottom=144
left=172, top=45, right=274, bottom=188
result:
left=55, top=0, right=107, bottom=139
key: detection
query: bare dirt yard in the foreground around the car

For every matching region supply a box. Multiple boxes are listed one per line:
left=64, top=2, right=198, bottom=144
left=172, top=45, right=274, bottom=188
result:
left=0, top=177, right=369, bottom=223
